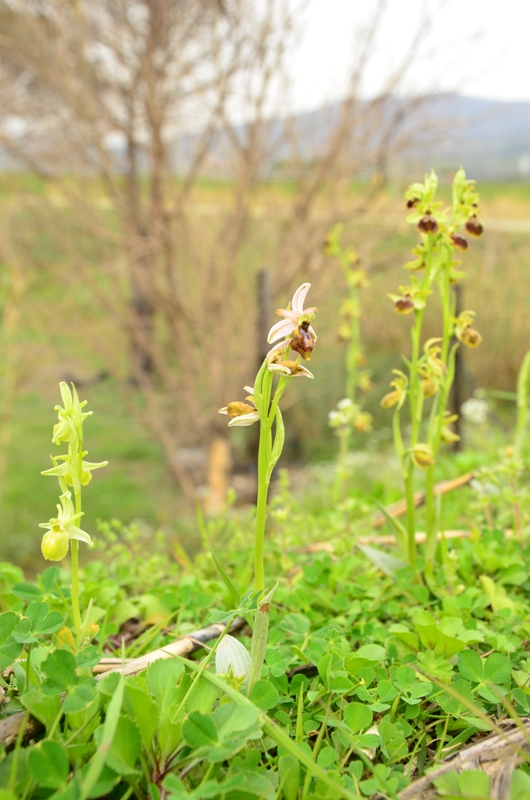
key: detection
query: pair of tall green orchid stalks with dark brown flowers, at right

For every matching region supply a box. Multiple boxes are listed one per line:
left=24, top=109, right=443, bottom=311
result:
left=381, top=169, right=483, bottom=565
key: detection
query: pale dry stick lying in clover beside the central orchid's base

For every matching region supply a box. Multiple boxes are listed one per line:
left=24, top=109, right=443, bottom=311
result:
left=0, top=617, right=246, bottom=750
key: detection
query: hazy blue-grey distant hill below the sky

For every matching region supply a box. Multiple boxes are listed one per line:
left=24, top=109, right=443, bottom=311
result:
left=170, top=94, right=530, bottom=181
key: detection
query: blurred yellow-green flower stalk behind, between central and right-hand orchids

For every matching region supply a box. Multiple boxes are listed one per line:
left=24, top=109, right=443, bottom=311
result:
left=324, top=224, right=372, bottom=500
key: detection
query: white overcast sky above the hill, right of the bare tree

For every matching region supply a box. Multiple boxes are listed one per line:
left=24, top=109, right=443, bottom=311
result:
left=291, top=0, right=530, bottom=111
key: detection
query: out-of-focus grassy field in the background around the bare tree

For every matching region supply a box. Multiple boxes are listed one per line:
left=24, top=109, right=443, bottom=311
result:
left=0, top=174, right=530, bottom=569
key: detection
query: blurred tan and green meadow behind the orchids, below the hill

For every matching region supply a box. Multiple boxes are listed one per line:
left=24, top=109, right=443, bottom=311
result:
left=0, top=174, right=530, bottom=569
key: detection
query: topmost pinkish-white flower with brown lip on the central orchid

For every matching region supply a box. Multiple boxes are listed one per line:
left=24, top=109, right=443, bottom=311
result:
left=267, top=283, right=317, bottom=362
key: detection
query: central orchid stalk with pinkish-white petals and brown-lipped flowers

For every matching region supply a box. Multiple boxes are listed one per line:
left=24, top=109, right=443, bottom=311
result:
left=219, top=283, right=317, bottom=592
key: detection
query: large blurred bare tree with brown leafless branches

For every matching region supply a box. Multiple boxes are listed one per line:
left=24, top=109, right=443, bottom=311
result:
left=0, top=0, right=456, bottom=500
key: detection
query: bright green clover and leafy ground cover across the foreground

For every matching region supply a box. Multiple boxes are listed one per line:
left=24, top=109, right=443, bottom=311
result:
left=0, top=462, right=530, bottom=800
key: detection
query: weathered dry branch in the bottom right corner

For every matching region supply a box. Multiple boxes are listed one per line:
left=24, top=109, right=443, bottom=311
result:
left=399, top=717, right=530, bottom=800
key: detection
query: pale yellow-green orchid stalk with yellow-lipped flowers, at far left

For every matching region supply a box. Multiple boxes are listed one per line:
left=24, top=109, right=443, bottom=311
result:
left=39, top=381, right=108, bottom=646
